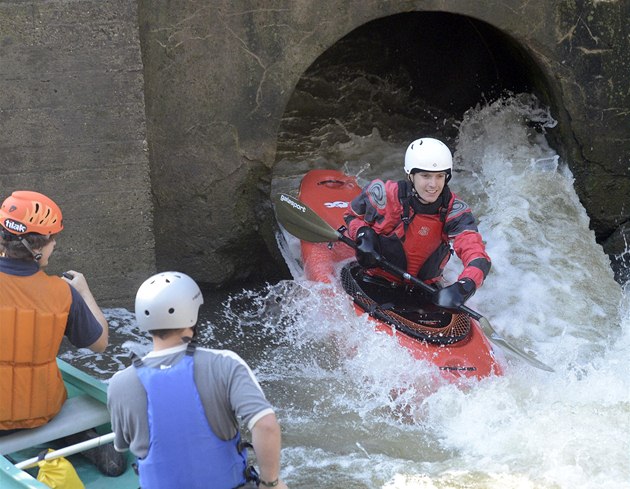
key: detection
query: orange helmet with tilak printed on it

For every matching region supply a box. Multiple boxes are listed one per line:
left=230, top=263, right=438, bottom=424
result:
left=0, top=190, right=63, bottom=236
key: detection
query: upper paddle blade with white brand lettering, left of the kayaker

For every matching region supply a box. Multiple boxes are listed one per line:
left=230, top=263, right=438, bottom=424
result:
left=273, top=194, right=341, bottom=243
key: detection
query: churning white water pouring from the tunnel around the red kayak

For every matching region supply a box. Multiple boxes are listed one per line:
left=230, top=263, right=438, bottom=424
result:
left=61, top=97, right=630, bottom=489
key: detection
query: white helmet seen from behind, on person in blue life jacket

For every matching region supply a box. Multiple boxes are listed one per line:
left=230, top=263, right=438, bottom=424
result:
left=136, top=272, right=203, bottom=331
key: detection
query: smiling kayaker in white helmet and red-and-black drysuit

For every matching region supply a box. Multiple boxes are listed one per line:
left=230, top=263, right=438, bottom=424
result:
left=344, top=138, right=491, bottom=310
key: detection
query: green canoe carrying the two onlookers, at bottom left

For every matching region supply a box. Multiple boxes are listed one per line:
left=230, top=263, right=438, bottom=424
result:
left=0, top=359, right=139, bottom=489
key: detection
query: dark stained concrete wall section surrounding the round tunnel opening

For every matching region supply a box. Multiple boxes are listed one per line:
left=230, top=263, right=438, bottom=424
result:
left=139, top=0, right=630, bottom=283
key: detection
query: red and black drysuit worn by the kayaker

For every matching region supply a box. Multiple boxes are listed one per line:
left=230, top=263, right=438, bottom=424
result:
left=344, top=180, right=491, bottom=298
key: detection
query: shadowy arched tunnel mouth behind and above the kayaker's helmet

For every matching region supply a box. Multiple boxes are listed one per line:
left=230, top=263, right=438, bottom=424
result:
left=276, top=11, right=561, bottom=163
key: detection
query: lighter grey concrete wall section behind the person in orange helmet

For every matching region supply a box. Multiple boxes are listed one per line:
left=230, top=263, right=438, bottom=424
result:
left=0, top=0, right=155, bottom=306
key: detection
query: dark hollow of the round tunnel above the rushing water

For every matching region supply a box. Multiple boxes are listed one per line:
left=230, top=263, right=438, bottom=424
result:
left=277, top=12, right=553, bottom=161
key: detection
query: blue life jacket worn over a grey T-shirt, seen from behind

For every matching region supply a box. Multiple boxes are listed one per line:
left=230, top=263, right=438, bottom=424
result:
left=134, top=343, right=247, bottom=489
